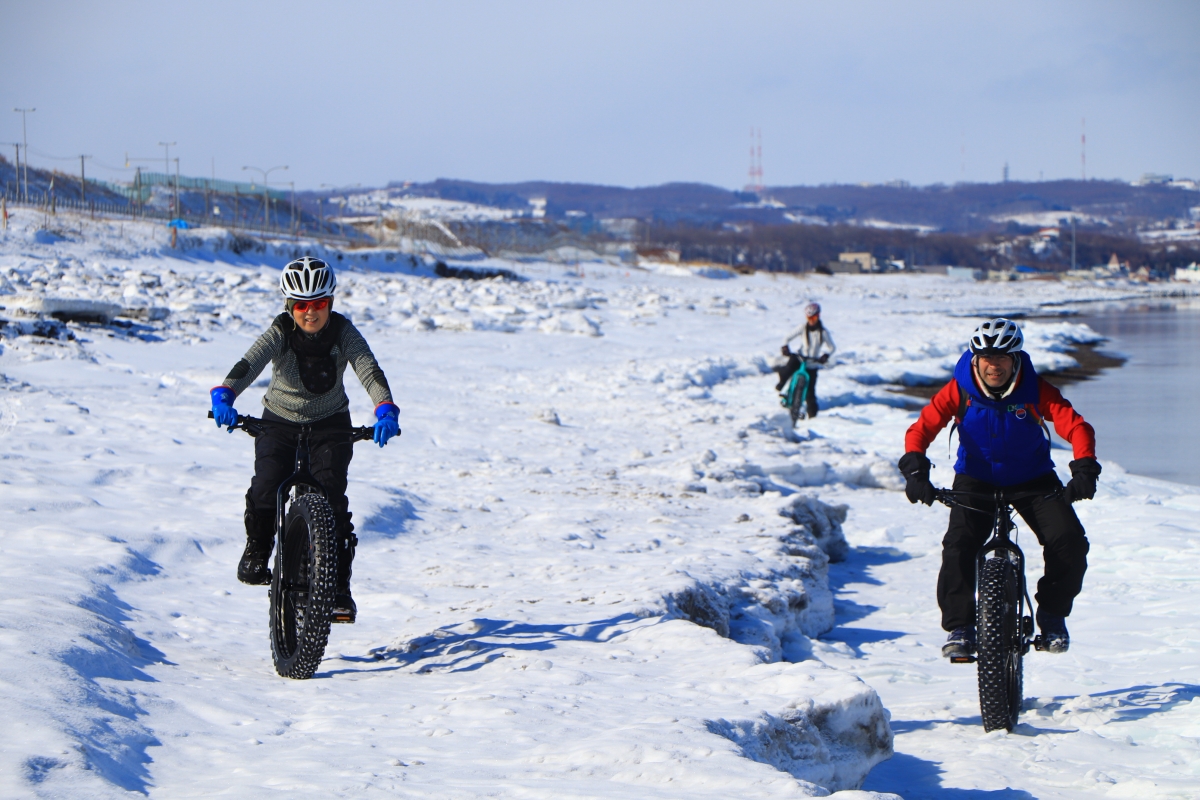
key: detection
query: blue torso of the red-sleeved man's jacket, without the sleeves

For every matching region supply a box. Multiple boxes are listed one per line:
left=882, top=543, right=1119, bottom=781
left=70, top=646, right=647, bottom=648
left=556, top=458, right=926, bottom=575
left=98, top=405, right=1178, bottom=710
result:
left=954, top=351, right=1054, bottom=486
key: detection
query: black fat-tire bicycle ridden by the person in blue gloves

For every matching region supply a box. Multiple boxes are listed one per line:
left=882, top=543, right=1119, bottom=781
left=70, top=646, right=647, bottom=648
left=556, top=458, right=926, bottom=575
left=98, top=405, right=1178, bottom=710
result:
left=209, top=411, right=376, bottom=680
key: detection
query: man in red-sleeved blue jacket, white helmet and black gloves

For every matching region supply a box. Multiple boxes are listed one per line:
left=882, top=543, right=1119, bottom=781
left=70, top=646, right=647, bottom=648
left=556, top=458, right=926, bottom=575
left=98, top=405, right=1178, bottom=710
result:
left=900, top=319, right=1100, bottom=657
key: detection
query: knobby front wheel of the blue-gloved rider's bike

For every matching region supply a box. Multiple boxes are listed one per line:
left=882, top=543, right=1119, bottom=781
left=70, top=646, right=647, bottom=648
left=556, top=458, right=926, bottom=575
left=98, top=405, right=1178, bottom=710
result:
left=271, top=494, right=337, bottom=680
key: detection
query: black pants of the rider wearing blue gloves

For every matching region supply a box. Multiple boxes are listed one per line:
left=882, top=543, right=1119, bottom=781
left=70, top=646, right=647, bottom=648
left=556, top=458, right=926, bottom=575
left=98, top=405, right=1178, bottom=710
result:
left=246, top=411, right=354, bottom=534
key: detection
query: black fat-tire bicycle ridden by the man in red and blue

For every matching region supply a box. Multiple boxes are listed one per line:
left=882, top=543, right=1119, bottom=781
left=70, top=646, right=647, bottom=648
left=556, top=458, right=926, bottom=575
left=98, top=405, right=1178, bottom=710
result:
left=934, top=489, right=1063, bottom=730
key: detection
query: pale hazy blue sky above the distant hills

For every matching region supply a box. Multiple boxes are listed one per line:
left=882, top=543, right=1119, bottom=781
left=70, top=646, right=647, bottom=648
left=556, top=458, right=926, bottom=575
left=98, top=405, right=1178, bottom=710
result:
left=0, top=0, right=1200, bottom=188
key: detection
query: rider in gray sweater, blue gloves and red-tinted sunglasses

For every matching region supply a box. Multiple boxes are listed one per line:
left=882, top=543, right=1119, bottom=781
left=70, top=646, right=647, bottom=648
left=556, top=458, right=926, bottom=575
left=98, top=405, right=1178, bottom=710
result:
left=211, top=257, right=400, bottom=621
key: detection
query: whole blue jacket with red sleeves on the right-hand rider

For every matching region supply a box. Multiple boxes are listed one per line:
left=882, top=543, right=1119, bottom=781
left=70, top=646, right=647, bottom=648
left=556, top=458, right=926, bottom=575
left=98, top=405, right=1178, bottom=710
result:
left=905, top=351, right=1096, bottom=486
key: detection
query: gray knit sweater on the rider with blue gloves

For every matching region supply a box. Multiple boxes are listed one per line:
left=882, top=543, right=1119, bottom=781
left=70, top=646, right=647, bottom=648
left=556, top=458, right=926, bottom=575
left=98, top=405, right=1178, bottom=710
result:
left=221, top=312, right=391, bottom=425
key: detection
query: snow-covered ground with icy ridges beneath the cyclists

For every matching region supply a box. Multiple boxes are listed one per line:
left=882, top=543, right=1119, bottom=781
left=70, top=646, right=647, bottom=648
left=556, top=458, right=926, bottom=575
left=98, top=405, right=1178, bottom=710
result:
left=0, top=212, right=1200, bottom=800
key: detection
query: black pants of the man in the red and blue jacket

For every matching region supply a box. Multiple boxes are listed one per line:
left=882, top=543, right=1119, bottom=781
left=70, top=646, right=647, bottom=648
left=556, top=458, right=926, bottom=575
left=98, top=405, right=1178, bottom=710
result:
left=937, top=473, right=1088, bottom=631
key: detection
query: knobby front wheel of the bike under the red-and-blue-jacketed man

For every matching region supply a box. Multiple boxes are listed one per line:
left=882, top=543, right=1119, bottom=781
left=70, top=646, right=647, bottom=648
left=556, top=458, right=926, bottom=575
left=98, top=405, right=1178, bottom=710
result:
left=976, top=552, right=1025, bottom=730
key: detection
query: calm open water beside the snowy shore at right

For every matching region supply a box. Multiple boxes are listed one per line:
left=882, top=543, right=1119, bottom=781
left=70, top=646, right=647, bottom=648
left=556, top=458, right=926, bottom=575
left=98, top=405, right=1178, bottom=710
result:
left=1063, top=301, right=1200, bottom=486
